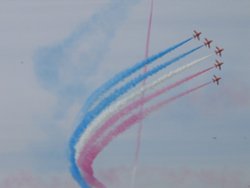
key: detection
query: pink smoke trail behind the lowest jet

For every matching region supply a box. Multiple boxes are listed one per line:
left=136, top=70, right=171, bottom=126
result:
left=79, top=81, right=212, bottom=187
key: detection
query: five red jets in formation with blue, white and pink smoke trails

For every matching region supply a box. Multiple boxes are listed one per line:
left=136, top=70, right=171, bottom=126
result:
left=70, top=30, right=224, bottom=188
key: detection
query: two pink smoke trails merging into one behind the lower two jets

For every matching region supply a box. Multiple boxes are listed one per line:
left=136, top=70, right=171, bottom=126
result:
left=77, top=67, right=214, bottom=187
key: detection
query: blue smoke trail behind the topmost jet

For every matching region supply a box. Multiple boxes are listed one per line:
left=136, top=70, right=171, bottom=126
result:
left=83, top=37, right=193, bottom=112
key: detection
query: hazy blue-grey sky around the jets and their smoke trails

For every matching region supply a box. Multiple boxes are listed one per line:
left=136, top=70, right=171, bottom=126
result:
left=0, top=0, right=250, bottom=188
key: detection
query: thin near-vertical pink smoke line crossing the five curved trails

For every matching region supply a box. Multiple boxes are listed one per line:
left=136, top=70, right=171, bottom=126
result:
left=131, top=0, right=154, bottom=188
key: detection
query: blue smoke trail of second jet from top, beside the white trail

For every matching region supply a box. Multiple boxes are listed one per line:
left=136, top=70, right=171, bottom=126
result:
left=70, top=45, right=203, bottom=186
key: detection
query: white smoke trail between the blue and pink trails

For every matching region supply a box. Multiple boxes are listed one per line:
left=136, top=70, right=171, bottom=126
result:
left=76, top=55, right=211, bottom=158
